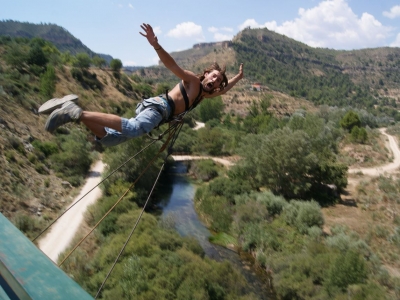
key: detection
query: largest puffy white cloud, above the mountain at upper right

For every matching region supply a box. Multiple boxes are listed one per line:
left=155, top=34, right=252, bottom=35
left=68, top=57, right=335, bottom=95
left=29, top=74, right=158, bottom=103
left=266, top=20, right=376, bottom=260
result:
left=239, top=0, right=392, bottom=49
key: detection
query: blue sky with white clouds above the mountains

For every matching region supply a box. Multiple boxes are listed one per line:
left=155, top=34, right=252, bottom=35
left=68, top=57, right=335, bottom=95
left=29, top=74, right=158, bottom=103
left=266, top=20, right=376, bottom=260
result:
left=0, top=0, right=400, bottom=66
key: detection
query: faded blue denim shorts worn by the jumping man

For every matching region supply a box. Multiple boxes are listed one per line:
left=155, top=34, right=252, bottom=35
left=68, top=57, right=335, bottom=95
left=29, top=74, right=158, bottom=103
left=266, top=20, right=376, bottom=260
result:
left=95, top=96, right=171, bottom=147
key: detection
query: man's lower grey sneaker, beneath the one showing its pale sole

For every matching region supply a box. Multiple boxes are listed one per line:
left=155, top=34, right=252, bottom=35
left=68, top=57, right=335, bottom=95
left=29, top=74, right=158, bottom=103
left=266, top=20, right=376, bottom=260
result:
left=44, top=101, right=83, bottom=132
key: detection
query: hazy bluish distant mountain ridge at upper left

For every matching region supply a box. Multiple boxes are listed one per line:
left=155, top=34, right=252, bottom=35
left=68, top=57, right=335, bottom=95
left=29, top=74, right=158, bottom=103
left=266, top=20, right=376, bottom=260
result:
left=0, top=20, right=113, bottom=63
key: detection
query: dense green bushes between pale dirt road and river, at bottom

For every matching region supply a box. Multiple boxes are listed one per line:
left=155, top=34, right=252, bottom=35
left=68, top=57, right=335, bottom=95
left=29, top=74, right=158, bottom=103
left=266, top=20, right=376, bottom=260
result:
left=63, top=208, right=256, bottom=300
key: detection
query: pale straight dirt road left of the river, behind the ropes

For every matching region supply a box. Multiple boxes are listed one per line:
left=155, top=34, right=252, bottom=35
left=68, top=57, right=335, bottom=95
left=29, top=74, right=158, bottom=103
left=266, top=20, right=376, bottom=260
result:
left=39, top=161, right=104, bottom=263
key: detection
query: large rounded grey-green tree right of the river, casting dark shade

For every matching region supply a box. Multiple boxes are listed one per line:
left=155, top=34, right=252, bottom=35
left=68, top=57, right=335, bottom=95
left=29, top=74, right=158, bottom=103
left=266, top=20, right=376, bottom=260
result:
left=237, top=127, right=347, bottom=198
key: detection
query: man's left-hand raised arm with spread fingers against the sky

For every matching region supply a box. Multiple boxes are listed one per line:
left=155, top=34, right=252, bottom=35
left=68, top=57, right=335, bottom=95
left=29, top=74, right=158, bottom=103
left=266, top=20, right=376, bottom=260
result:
left=139, top=23, right=195, bottom=81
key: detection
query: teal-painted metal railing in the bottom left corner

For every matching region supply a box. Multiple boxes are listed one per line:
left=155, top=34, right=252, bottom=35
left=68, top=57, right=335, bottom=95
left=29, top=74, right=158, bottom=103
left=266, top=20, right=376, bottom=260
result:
left=0, top=213, right=93, bottom=300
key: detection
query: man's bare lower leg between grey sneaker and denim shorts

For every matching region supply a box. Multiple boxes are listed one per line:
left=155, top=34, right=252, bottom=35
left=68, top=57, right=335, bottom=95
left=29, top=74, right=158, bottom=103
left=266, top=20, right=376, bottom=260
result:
left=79, top=111, right=122, bottom=138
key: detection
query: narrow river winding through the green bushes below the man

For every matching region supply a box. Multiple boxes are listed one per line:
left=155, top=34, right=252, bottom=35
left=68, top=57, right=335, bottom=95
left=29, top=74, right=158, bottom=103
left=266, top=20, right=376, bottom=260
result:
left=157, top=162, right=274, bottom=300
